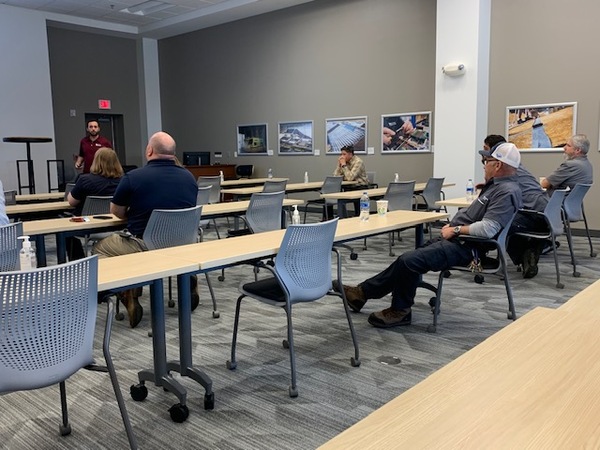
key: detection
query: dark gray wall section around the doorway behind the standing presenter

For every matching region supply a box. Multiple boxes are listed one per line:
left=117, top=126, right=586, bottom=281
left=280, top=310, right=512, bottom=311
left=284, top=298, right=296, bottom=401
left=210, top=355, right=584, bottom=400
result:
left=48, top=26, right=145, bottom=179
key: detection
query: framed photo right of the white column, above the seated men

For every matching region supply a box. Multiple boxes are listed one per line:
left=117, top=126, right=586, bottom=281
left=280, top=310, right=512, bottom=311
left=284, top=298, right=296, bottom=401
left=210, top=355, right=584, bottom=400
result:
left=505, top=102, right=577, bottom=152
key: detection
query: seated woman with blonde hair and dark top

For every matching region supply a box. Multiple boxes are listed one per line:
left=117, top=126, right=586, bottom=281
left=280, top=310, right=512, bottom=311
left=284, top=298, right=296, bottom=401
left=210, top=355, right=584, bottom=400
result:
left=66, top=147, right=123, bottom=261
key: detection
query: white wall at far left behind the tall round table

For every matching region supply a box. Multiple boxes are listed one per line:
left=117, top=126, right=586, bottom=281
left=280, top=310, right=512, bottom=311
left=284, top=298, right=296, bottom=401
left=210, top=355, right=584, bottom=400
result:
left=0, top=5, right=56, bottom=193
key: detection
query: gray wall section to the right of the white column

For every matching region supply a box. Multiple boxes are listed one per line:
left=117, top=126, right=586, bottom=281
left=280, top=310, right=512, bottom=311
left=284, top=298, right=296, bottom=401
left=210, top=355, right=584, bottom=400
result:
left=489, top=0, right=600, bottom=230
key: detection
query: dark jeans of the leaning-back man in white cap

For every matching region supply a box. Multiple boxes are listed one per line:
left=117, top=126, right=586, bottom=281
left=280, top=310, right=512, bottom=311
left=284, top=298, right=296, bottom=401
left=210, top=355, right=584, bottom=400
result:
left=360, top=238, right=473, bottom=310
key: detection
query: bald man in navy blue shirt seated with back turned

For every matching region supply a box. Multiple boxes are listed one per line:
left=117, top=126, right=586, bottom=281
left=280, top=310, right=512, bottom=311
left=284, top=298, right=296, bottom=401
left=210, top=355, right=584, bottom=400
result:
left=94, top=131, right=199, bottom=328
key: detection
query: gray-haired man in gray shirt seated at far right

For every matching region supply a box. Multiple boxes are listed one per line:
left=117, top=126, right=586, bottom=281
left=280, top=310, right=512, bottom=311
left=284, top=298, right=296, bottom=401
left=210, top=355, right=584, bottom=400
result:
left=542, top=134, right=594, bottom=195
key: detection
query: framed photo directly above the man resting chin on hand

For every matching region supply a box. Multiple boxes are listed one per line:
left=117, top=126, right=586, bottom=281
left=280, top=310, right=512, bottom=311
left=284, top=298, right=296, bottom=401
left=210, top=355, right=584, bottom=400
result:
left=325, top=116, right=367, bottom=155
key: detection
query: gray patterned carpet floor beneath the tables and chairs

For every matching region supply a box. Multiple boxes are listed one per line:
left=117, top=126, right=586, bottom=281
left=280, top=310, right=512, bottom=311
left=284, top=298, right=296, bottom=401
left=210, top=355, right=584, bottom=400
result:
left=0, top=217, right=600, bottom=450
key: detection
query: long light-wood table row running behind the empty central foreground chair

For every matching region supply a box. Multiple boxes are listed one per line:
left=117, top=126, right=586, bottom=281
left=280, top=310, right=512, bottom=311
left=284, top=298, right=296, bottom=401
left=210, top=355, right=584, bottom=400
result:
left=98, top=211, right=448, bottom=420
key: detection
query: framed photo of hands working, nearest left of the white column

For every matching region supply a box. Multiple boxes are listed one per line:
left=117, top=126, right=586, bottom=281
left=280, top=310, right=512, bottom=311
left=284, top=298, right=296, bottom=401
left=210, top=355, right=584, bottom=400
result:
left=381, top=111, right=431, bottom=153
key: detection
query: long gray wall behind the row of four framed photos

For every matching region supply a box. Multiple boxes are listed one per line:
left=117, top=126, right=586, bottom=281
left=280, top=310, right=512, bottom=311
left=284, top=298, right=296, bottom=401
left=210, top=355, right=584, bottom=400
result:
left=159, top=0, right=436, bottom=183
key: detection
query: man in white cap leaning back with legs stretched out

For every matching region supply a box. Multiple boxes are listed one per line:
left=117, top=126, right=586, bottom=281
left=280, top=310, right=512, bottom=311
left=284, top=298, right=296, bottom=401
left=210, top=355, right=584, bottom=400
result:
left=334, top=143, right=522, bottom=328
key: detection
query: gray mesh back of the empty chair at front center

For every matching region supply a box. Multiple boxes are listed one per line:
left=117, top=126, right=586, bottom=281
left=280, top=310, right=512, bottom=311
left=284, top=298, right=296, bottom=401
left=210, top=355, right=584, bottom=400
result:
left=275, top=218, right=338, bottom=303
